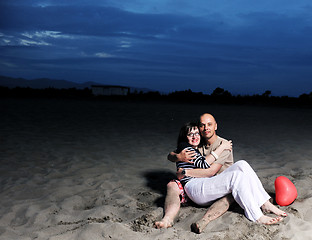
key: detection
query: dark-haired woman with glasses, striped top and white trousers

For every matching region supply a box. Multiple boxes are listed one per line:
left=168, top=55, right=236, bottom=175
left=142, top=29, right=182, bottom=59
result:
left=177, top=124, right=287, bottom=224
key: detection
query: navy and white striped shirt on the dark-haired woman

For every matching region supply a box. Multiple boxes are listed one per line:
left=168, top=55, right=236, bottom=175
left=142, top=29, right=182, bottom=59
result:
left=176, top=143, right=210, bottom=186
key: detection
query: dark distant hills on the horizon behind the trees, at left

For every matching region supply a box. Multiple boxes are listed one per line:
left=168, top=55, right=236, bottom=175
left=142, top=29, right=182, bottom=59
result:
left=0, top=76, right=153, bottom=93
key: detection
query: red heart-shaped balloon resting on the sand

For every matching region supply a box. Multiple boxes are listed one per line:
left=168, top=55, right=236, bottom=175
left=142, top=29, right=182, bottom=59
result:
left=274, top=176, right=298, bottom=206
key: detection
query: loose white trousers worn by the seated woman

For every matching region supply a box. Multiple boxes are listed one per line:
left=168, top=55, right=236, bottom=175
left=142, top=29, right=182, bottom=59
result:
left=184, top=160, right=270, bottom=222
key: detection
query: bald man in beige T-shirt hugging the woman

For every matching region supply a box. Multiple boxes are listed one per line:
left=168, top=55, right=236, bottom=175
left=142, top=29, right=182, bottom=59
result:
left=155, top=113, right=234, bottom=233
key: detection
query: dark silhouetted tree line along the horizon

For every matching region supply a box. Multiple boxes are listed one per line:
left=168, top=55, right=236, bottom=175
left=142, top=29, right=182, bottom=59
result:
left=0, top=86, right=312, bottom=106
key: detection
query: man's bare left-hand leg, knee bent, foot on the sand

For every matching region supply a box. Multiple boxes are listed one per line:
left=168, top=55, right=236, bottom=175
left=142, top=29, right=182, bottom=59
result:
left=155, top=181, right=180, bottom=228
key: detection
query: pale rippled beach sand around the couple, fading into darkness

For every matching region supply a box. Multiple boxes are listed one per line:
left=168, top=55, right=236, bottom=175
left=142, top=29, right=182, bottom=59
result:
left=0, top=99, right=312, bottom=240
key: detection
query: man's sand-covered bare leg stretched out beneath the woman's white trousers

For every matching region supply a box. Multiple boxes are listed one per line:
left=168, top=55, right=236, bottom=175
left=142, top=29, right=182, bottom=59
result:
left=191, top=194, right=234, bottom=233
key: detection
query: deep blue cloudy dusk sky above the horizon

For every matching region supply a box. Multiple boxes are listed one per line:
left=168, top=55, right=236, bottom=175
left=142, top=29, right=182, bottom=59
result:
left=0, top=0, right=312, bottom=97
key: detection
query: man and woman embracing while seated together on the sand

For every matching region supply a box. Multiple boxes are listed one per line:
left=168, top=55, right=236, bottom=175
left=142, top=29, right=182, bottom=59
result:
left=155, top=113, right=287, bottom=233
